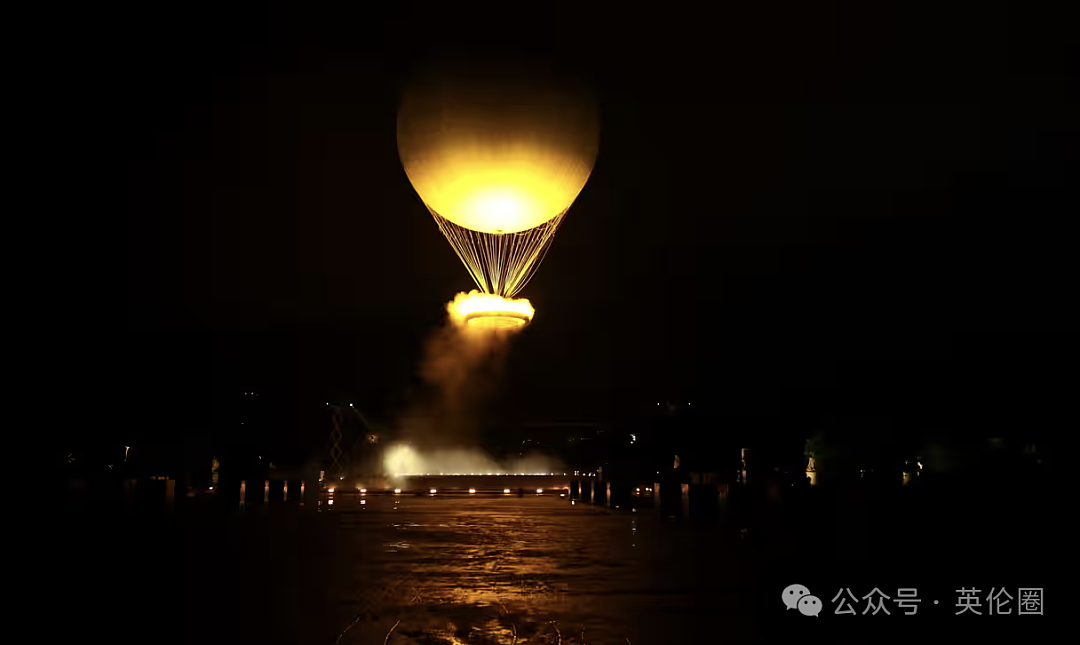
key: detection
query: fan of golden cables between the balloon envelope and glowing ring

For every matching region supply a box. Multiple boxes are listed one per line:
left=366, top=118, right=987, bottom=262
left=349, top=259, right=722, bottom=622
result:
left=429, top=207, right=566, bottom=298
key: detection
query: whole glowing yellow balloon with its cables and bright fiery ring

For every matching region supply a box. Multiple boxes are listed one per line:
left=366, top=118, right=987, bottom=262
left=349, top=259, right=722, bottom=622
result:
left=397, top=62, right=599, bottom=328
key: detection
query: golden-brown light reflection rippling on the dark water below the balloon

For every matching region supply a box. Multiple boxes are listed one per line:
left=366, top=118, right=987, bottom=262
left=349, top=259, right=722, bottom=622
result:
left=332, top=497, right=642, bottom=645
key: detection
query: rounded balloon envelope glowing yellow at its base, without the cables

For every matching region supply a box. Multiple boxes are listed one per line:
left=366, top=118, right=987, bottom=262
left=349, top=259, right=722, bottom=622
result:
left=397, top=66, right=599, bottom=233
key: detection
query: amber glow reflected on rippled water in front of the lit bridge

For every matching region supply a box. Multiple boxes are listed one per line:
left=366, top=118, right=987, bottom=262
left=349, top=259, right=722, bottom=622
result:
left=332, top=497, right=637, bottom=645
